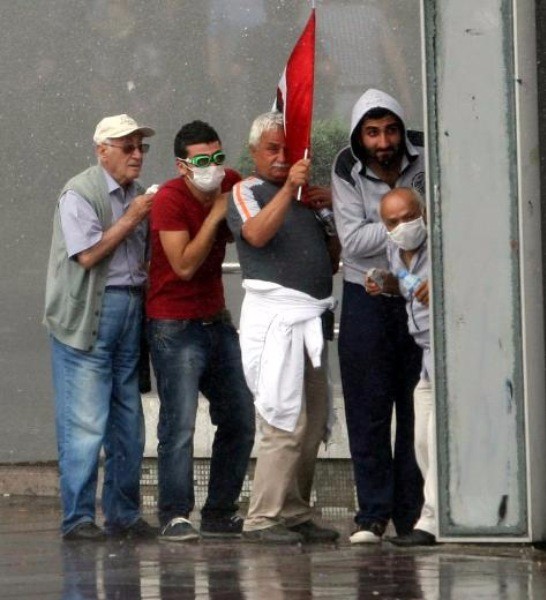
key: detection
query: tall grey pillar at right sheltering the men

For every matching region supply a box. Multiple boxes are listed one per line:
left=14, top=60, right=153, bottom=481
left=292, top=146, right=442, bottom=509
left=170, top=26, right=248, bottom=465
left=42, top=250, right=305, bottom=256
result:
left=423, top=0, right=546, bottom=541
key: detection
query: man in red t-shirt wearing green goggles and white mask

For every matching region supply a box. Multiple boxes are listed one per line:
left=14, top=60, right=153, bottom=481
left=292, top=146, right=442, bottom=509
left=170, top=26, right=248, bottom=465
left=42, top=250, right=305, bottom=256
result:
left=146, top=121, right=255, bottom=542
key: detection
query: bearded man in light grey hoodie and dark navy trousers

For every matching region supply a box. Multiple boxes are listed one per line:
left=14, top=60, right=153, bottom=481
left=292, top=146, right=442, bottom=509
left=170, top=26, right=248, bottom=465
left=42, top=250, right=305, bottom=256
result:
left=332, top=89, right=425, bottom=544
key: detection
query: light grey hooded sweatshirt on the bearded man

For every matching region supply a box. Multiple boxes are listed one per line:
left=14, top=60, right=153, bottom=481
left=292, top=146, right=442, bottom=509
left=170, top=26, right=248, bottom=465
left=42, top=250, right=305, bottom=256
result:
left=332, top=89, right=425, bottom=286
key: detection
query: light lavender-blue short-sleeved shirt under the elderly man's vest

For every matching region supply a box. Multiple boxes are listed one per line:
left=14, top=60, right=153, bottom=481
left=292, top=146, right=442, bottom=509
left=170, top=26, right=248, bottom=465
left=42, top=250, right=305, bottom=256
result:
left=59, top=169, right=148, bottom=286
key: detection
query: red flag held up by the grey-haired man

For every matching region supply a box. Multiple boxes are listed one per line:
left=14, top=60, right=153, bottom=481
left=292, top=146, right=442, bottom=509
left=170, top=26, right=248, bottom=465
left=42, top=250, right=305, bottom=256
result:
left=274, top=8, right=315, bottom=164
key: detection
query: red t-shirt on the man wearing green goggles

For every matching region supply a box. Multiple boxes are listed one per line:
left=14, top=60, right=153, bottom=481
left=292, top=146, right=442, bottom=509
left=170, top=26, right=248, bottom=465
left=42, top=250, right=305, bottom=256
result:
left=146, top=169, right=241, bottom=319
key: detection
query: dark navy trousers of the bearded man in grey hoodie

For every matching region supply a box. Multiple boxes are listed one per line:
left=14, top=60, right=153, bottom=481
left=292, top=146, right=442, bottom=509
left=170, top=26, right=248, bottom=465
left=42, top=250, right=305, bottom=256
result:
left=339, top=282, right=423, bottom=535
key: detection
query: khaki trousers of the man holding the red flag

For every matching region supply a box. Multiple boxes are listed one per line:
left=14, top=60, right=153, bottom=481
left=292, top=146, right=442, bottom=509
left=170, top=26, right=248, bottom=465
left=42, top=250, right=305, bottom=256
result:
left=244, top=342, right=328, bottom=531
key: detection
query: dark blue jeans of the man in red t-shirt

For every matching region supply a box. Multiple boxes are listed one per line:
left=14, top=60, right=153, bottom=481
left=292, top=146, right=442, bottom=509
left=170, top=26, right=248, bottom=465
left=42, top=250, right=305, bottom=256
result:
left=148, top=319, right=255, bottom=525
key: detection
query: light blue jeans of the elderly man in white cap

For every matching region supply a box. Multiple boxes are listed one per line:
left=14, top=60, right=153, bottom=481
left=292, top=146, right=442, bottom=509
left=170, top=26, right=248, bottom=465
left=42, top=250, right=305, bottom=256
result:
left=50, top=290, right=144, bottom=534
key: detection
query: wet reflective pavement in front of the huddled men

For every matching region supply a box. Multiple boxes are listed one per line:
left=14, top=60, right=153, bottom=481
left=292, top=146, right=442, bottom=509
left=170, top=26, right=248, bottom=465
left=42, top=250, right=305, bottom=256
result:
left=0, top=497, right=546, bottom=600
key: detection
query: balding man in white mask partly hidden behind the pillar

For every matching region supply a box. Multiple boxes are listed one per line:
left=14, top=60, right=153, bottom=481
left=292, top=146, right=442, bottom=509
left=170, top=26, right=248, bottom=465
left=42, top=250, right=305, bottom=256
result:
left=365, top=188, right=436, bottom=546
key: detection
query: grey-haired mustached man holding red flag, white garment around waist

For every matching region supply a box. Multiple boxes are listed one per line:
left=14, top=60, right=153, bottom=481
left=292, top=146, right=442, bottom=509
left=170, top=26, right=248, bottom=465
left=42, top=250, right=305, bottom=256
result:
left=224, top=2, right=339, bottom=544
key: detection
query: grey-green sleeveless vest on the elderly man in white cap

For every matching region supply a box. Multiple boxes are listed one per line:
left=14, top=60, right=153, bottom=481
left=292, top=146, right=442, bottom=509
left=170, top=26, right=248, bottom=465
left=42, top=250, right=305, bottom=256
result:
left=43, top=165, right=128, bottom=350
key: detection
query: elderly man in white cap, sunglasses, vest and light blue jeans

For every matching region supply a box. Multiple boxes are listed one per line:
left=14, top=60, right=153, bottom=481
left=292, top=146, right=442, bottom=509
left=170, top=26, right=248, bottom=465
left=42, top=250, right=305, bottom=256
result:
left=44, top=115, right=156, bottom=541
